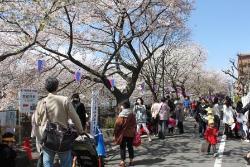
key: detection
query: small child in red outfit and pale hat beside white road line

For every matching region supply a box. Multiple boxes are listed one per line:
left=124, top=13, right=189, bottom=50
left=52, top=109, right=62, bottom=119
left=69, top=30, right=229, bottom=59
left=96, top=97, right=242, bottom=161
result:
left=204, top=119, right=218, bottom=156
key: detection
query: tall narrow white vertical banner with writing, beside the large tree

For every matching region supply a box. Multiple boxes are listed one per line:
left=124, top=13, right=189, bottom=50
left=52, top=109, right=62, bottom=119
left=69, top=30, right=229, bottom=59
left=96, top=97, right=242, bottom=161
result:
left=90, top=91, right=99, bottom=136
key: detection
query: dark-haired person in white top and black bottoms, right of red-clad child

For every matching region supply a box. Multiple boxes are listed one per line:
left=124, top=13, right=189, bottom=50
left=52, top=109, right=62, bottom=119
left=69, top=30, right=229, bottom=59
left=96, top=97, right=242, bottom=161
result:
left=222, top=98, right=234, bottom=138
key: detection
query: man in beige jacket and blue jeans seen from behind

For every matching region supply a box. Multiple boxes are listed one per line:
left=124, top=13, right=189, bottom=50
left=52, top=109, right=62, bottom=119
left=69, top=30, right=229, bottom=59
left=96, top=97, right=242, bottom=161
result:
left=35, top=77, right=84, bottom=167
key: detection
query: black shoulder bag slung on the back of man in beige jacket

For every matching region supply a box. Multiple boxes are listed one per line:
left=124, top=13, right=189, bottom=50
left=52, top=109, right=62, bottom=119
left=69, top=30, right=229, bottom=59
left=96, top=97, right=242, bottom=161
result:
left=41, top=102, right=78, bottom=152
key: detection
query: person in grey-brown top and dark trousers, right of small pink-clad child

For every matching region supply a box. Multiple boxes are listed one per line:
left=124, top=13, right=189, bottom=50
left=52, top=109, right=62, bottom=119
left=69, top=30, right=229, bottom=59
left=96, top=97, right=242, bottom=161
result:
left=175, top=101, right=184, bottom=134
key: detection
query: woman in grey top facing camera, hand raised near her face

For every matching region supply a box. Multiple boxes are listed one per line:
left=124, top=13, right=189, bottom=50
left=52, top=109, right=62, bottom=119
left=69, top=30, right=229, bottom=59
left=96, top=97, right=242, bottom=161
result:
left=133, top=98, right=152, bottom=142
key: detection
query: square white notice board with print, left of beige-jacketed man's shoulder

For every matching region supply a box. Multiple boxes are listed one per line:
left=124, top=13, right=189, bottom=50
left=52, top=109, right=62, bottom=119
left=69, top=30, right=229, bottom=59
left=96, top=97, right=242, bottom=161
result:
left=19, top=89, right=38, bottom=112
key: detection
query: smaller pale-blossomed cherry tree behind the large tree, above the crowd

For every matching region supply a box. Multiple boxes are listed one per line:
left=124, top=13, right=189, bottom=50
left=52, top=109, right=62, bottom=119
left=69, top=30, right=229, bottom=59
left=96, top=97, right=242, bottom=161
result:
left=142, top=42, right=206, bottom=100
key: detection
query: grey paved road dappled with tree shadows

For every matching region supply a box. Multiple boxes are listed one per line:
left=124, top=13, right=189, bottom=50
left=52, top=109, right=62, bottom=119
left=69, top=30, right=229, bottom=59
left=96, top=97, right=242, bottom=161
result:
left=106, top=119, right=250, bottom=167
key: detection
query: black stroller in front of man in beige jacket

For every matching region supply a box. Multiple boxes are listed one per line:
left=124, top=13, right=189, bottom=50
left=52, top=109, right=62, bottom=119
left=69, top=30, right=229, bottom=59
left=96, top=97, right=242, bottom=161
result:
left=72, top=134, right=100, bottom=167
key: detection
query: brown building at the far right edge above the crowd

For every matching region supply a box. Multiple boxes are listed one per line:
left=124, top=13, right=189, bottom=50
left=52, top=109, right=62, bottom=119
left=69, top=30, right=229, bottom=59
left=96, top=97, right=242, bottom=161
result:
left=237, top=53, right=250, bottom=94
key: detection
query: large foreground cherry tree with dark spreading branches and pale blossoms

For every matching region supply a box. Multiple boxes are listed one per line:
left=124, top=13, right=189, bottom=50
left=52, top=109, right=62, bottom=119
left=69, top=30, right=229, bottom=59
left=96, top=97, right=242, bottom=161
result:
left=0, top=0, right=192, bottom=103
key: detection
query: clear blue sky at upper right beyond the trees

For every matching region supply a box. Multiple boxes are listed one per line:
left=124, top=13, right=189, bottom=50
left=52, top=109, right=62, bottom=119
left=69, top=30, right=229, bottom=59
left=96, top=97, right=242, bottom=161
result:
left=189, top=0, right=250, bottom=70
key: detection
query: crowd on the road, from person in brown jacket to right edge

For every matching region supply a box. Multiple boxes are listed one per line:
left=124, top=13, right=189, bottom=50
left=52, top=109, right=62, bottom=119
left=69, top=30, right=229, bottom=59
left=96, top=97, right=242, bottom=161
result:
left=114, top=96, right=250, bottom=167
